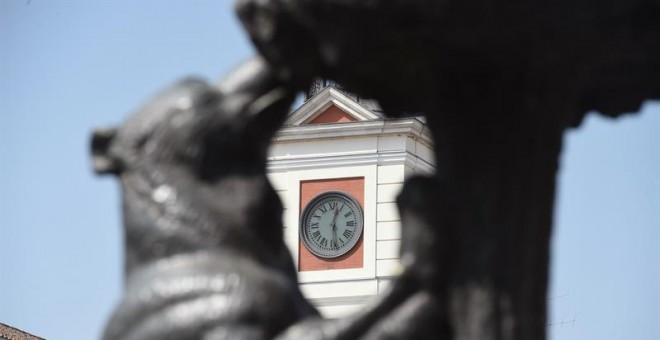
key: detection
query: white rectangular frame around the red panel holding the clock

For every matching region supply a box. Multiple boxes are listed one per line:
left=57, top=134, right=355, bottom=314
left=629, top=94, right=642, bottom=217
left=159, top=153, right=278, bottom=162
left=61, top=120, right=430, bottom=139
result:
left=284, top=164, right=378, bottom=283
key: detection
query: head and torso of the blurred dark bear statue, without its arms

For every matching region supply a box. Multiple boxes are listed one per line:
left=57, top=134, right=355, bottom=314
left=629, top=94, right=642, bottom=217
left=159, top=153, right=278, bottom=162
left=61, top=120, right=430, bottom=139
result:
left=92, top=58, right=317, bottom=339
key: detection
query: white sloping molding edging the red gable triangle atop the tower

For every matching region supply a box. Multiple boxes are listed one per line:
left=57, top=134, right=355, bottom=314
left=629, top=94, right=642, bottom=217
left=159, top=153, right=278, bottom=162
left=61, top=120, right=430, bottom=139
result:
left=284, top=87, right=383, bottom=126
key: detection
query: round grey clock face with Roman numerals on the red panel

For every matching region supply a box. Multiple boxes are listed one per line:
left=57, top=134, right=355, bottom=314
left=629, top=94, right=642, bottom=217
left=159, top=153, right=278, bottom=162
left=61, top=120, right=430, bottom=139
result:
left=300, top=191, right=363, bottom=258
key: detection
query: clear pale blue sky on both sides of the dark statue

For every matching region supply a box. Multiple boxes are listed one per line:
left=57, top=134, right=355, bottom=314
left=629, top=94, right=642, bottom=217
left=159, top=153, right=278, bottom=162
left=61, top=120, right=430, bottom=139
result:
left=0, top=0, right=660, bottom=340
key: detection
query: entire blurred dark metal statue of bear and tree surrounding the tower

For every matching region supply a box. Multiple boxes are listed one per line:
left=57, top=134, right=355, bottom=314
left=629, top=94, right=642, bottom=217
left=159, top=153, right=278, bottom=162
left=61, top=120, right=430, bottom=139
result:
left=93, top=0, right=660, bottom=340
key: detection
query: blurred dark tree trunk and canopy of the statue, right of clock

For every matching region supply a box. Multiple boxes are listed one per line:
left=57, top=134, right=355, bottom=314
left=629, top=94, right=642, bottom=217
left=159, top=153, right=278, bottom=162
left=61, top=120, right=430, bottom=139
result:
left=237, top=0, right=660, bottom=340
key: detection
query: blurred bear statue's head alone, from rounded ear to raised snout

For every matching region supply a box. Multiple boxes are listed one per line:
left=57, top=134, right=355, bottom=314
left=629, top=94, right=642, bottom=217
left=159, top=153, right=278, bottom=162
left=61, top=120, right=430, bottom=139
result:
left=92, top=58, right=292, bottom=181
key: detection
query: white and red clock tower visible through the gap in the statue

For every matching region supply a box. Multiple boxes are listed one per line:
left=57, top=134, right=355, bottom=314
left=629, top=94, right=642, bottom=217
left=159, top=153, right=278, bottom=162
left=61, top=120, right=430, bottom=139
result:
left=268, top=81, right=434, bottom=318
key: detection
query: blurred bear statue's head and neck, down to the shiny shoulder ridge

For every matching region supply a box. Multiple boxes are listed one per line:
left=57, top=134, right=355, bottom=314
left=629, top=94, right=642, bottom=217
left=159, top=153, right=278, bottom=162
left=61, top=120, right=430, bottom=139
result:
left=92, top=58, right=294, bottom=271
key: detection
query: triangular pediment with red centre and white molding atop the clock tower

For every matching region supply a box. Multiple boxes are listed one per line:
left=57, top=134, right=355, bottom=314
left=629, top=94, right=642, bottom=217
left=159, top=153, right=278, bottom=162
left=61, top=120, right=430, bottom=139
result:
left=285, top=87, right=382, bottom=126
